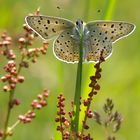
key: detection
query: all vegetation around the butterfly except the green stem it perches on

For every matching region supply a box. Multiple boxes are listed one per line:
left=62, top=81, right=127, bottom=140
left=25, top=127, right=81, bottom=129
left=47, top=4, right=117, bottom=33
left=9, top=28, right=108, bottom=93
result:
left=0, top=0, right=140, bottom=140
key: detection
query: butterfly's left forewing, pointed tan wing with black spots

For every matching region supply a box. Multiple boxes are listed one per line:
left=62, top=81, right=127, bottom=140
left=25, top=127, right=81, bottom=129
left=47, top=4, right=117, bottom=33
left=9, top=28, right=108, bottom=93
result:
left=25, top=16, right=75, bottom=39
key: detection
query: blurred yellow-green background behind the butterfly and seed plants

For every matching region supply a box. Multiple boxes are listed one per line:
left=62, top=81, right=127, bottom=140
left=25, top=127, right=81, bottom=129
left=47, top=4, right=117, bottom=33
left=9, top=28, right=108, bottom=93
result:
left=0, top=0, right=140, bottom=140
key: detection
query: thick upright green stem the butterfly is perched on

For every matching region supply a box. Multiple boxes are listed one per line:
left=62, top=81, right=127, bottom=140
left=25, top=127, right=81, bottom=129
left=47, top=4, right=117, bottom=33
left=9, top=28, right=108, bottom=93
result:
left=71, top=34, right=83, bottom=133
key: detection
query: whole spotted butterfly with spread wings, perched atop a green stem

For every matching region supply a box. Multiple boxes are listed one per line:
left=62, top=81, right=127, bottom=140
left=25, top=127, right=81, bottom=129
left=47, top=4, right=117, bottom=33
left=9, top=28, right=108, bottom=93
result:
left=25, top=15, right=135, bottom=63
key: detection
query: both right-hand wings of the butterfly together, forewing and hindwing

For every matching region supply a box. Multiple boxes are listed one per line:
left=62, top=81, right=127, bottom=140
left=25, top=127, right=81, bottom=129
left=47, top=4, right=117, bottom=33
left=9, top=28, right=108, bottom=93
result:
left=85, top=21, right=135, bottom=62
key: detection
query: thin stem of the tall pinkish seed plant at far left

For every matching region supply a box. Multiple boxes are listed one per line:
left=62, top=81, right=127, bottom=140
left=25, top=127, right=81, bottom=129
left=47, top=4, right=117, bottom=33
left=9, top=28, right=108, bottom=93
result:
left=2, top=56, right=24, bottom=140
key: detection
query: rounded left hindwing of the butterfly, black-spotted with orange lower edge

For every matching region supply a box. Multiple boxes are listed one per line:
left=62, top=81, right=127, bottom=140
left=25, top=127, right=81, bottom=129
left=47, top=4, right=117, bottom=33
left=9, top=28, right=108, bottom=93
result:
left=53, top=28, right=80, bottom=63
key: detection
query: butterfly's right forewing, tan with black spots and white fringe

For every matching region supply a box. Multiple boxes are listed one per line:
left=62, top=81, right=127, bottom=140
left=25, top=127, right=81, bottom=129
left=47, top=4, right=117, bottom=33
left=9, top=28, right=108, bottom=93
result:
left=86, top=21, right=135, bottom=43
